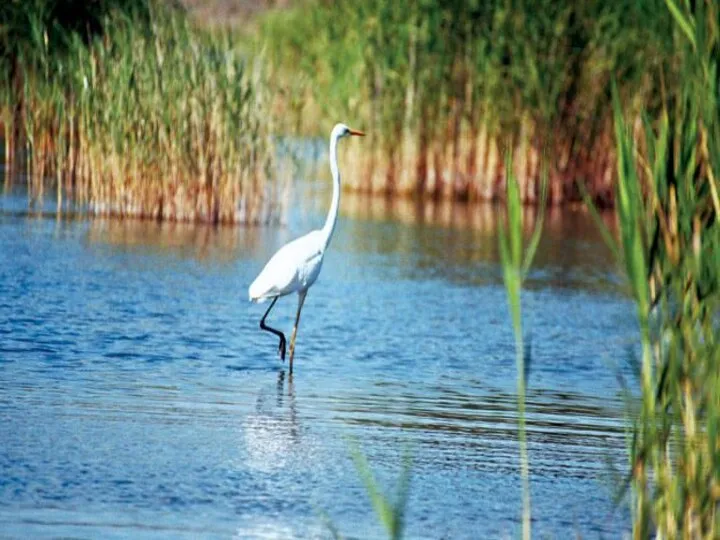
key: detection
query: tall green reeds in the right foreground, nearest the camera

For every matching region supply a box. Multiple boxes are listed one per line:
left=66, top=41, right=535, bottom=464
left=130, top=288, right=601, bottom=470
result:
left=614, top=0, right=720, bottom=539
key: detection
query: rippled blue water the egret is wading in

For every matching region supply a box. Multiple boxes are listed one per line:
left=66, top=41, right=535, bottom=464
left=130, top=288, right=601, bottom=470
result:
left=0, top=184, right=634, bottom=539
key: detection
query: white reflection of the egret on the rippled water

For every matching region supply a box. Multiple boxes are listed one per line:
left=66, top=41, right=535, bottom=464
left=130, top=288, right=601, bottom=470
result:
left=242, top=370, right=301, bottom=471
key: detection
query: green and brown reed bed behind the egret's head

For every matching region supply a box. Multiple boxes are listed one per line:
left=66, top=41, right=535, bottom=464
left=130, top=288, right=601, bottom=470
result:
left=259, top=0, right=673, bottom=205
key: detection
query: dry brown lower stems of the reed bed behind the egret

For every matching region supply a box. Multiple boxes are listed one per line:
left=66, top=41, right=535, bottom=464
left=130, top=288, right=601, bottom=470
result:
left=343, top=127, right=616, bottom=206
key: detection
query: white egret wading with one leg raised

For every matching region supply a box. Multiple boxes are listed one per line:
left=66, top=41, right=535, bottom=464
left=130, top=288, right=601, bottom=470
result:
left=249, top=124, right=365, bottom=373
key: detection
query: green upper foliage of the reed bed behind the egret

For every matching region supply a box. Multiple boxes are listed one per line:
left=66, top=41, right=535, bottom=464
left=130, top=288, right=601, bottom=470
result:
left=263, top=0, right=668, bottom=131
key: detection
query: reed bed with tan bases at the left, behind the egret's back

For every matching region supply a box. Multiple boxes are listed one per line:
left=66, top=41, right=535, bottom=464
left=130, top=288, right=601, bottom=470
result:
left=0, top=1, right=283, bottom=223
